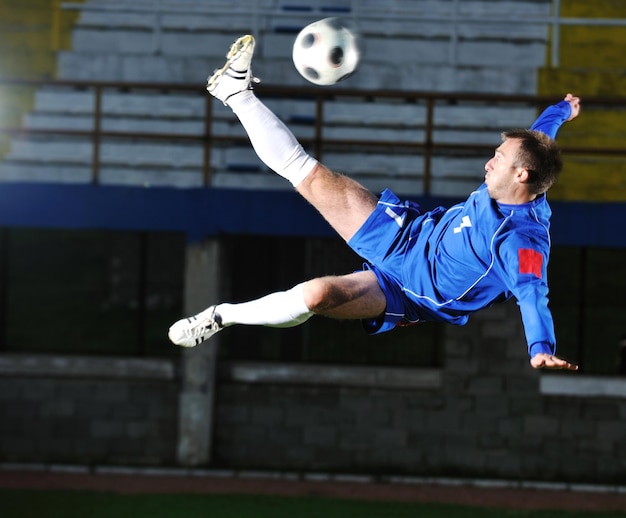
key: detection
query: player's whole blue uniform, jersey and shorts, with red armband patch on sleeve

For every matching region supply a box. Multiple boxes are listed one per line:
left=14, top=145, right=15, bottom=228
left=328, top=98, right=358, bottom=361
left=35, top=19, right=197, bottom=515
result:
left=348, top=97, right=571, bottom=357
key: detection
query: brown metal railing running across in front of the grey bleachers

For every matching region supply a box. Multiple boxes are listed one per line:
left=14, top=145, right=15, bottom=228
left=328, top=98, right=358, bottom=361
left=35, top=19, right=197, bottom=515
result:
left=0, top=79, right=626, bottom=195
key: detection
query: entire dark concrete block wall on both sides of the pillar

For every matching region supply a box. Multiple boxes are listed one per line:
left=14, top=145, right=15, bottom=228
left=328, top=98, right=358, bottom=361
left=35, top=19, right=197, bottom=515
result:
left=0, top=303, right=626, bottom=483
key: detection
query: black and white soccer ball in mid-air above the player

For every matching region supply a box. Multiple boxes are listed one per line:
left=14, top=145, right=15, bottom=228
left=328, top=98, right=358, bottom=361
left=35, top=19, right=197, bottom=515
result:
left=292, top=18, right=361, bottom=85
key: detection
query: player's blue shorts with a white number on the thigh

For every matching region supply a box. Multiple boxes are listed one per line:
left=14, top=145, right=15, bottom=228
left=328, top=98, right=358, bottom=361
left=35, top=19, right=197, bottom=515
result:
left=348, top=189, right=443, bottom=333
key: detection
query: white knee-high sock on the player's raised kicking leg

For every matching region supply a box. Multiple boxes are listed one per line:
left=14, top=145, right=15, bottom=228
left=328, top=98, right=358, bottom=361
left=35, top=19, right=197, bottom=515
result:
left=228, top=90, right=317, bottom=187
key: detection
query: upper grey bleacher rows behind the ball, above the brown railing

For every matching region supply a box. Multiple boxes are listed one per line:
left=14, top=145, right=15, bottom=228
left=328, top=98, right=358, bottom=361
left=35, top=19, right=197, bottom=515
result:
left=59, top=0, right=550, bottom=88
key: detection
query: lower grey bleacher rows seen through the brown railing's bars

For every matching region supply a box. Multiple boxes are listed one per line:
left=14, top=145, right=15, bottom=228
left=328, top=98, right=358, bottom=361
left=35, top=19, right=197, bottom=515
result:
left=0, top=88, right=534, bottom=194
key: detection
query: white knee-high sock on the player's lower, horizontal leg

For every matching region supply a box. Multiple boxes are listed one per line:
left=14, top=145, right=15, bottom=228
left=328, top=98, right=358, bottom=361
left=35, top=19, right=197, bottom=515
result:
left=215, top=283, right=313, bottom=327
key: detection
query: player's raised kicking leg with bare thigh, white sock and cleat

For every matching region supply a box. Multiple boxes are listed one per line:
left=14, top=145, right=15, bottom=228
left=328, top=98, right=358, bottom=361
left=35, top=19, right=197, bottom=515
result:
left=207, top=36, right=377, bottom=241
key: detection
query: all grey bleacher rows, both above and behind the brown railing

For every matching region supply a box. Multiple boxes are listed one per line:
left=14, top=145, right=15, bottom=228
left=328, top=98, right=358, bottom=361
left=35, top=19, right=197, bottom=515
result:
left=0, top=0, right=550, bottom=196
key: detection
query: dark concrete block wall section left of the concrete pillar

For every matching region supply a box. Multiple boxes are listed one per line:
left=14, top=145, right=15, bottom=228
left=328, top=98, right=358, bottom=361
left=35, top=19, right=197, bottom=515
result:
left=0, top=355, right=178, bottom=465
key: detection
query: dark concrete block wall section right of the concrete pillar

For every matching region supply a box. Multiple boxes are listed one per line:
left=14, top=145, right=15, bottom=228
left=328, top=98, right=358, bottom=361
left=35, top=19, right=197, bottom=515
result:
left=215, top=302, right=626, bottom=483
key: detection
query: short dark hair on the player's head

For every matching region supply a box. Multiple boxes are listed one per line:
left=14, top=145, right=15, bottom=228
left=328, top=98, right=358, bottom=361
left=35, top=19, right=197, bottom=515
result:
left=502, top=129, right=563, bottom=194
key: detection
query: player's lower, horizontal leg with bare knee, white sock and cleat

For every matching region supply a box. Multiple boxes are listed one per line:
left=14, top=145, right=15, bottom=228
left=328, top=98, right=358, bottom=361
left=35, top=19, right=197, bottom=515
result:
left=169, top=271, right=386, bottom=347
